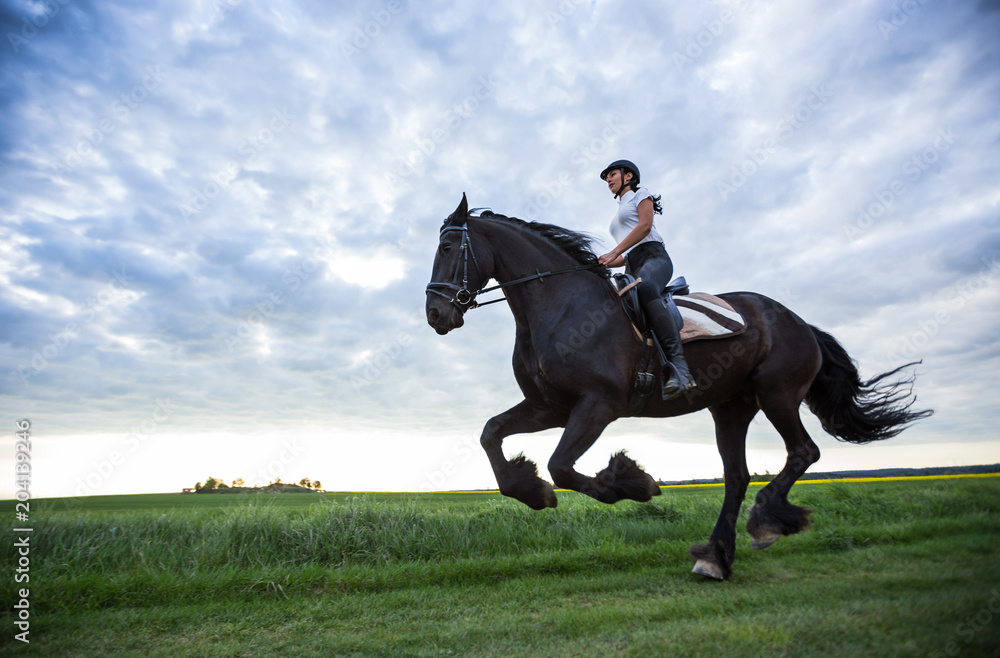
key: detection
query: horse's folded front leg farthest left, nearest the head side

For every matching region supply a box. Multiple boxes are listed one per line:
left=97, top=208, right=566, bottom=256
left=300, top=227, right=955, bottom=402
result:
left=479, top=400, right=563, bottom=510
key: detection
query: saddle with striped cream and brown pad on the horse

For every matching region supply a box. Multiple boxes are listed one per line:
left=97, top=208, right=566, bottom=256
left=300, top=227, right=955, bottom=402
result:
left=613, top=274, right=747, bottom=416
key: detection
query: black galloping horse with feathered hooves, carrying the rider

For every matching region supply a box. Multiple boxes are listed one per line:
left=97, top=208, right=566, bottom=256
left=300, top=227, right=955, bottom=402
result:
left=427, top=195, right=932, bottom=579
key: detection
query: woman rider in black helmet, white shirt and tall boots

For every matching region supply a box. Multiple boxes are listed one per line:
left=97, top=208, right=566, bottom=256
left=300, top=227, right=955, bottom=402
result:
left=599, top=160, right=695, bottom=400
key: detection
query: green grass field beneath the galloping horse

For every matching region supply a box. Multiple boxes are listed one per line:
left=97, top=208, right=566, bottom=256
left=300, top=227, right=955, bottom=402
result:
left=0, top=478, right=1000, bottom=656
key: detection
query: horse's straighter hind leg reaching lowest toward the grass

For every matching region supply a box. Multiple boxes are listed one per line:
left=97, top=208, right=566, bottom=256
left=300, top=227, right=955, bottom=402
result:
left=690, top=398, right=758, bottom=580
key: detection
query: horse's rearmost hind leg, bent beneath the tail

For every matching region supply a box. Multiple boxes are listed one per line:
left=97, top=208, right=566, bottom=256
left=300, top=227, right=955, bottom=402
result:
left=747, top=393, right=819, bottom=549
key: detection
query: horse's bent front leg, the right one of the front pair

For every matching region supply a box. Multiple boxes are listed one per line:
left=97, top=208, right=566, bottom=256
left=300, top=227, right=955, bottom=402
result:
left=549, top=400, right=660, bottom=503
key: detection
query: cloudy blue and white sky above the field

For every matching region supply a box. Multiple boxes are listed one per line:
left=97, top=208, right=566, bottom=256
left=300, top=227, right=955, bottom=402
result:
left=0, top=0, right=1000, bottom=498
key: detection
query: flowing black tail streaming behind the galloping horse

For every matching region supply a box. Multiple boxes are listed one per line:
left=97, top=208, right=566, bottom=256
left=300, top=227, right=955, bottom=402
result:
left=806, top=326, right=934, bottom=443
